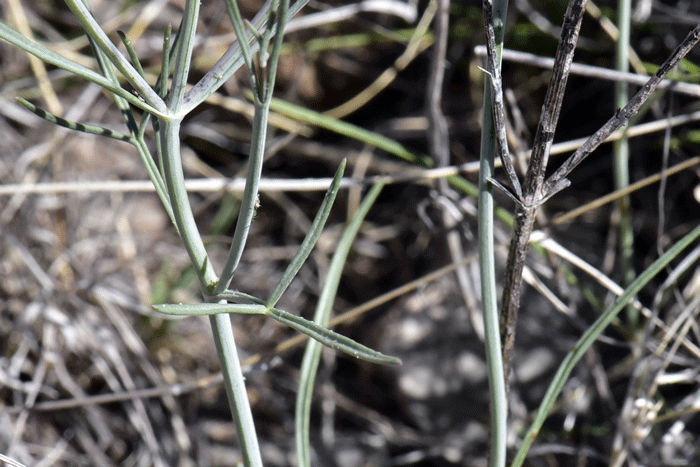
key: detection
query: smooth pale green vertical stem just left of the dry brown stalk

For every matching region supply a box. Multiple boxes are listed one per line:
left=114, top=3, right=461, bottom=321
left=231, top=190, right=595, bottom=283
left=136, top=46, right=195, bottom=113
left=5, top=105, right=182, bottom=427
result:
left=479, top=0, right=508, bottom=467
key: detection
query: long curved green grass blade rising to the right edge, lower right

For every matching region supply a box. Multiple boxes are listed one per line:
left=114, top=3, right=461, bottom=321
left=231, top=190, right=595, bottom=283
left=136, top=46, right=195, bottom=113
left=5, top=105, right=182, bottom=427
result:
left=512, top=221, right=700, bottom=467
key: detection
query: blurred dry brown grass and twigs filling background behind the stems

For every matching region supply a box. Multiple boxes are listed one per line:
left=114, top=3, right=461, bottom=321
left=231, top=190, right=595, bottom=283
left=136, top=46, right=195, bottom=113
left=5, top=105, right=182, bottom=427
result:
left=0, top=0, right=700, bottom=467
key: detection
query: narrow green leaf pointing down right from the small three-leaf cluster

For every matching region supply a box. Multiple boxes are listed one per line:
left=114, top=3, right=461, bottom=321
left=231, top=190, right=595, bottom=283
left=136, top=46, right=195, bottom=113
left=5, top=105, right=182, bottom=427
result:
left=267, top=308, right=401, bottom=365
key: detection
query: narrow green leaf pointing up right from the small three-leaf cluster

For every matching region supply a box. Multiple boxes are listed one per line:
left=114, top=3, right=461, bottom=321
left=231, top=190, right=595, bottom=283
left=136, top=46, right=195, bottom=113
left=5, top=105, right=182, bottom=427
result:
left=267, top=160, right=346, bottom=308
